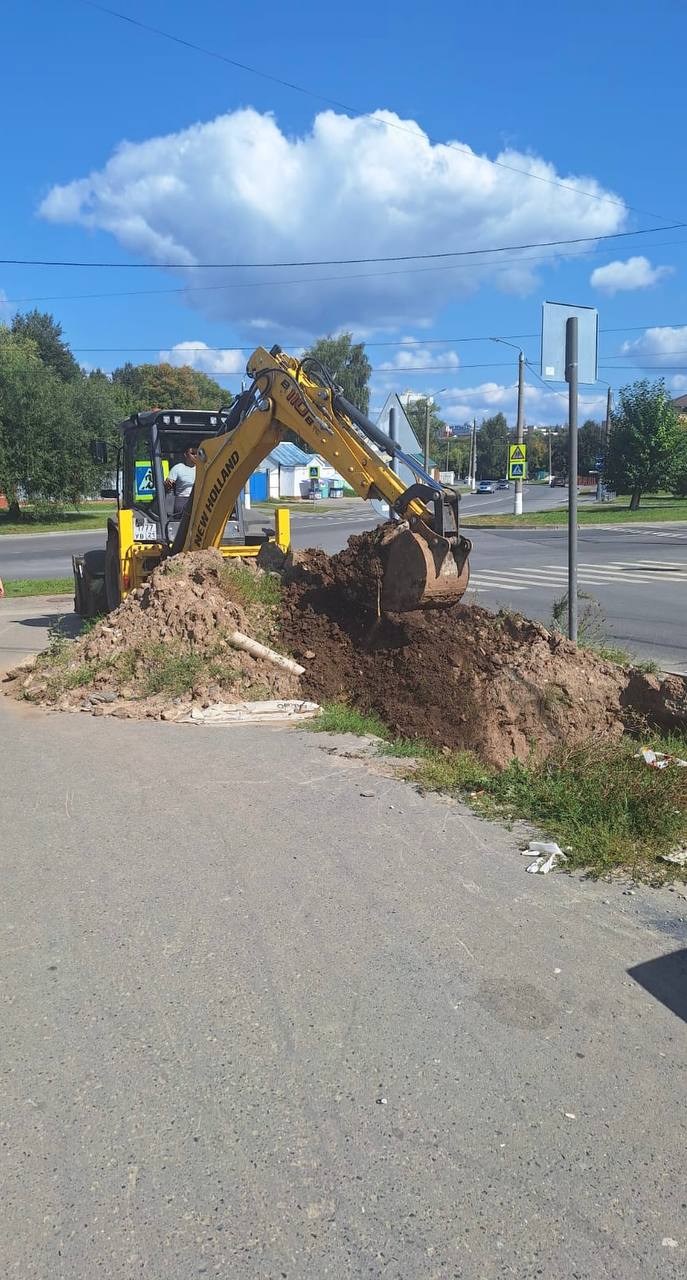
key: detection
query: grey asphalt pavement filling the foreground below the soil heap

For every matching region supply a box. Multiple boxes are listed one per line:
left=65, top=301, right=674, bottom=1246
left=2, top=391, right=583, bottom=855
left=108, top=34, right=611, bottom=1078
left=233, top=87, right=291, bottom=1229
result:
left=0, top=701, right=687, bottom=1280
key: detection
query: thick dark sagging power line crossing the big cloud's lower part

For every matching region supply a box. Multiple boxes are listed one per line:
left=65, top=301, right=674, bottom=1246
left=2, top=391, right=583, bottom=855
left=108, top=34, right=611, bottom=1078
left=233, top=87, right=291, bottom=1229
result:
left=0, top=222, right=687, bottom=271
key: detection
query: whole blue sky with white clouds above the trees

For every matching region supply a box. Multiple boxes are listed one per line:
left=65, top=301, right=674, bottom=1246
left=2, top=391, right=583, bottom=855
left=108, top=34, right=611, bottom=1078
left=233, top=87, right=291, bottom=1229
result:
left=0, top=0, right=687, bottom=422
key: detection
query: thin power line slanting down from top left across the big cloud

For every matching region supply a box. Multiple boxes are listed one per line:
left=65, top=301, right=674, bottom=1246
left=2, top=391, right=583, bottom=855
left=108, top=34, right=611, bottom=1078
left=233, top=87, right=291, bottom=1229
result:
left=72, top=0, right=663, bottom=218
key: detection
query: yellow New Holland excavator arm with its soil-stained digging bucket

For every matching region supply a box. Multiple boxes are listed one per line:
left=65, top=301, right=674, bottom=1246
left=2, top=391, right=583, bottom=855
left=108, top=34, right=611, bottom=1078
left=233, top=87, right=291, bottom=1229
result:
left=173, top=347, right=471, bottom=612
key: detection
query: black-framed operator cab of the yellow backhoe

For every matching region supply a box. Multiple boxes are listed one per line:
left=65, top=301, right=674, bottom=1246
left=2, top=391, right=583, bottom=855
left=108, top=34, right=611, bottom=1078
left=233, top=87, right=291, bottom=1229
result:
left=119, top=410, right=246, bottom=547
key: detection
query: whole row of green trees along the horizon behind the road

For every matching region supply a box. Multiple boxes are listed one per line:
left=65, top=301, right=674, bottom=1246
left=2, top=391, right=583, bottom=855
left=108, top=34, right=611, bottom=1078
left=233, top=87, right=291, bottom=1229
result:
left=0, top=311, right=687, bottom=518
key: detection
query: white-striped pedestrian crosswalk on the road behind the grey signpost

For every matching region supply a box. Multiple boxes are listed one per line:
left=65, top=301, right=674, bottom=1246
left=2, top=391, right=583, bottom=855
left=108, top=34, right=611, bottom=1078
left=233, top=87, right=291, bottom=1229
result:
left=470, top=559, right=687, bottom=591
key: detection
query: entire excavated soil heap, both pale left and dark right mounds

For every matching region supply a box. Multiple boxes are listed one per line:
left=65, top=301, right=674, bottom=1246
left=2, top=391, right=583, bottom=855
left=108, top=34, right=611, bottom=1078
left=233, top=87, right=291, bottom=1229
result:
left=10, top=530, right=687, bottom=768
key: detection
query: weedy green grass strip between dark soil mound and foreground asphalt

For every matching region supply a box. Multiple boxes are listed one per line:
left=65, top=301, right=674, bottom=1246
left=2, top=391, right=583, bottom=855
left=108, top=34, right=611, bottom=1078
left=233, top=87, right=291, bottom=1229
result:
left=310, top=703, right=687, bottom=882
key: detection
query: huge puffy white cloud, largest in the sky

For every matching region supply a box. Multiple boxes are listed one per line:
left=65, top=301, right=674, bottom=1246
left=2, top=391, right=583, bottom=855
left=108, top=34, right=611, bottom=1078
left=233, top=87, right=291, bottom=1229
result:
left=40, top=108, right=626, bottom=338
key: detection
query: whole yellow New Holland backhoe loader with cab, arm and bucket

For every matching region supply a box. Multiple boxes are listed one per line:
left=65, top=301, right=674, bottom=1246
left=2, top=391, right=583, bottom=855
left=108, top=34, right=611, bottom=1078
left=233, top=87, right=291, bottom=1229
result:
left=74, top=347, right=472, bottom=616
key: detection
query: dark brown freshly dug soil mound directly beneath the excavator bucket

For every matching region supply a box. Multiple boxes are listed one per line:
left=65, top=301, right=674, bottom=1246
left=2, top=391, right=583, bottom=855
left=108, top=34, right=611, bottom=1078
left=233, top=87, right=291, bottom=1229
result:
left=280, top=524, right=687, bottom=767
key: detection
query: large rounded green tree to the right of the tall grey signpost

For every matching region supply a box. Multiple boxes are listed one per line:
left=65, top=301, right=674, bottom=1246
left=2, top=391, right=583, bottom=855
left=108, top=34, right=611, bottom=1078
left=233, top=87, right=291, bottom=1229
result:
left=604, top=379, right=683, bottom=511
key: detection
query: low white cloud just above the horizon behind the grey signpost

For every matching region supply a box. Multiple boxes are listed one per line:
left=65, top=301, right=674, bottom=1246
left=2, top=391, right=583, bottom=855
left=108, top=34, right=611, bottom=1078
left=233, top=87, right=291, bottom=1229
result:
left=441, top=383, right=606, bottom=426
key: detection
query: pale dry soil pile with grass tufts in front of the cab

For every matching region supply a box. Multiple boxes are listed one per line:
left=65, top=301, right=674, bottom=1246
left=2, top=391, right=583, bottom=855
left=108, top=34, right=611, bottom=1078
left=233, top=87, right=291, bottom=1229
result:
left=12, top=550, right=299, bottom=719
